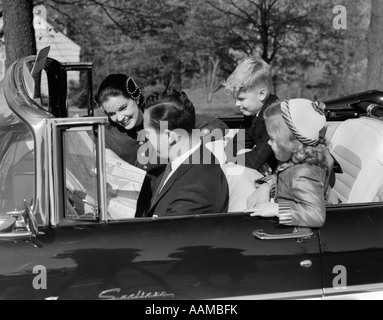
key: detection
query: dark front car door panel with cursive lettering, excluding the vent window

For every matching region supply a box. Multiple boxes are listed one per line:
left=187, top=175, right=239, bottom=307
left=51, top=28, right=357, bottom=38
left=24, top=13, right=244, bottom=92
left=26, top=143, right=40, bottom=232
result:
left=0, top=214, right=322, bottom=300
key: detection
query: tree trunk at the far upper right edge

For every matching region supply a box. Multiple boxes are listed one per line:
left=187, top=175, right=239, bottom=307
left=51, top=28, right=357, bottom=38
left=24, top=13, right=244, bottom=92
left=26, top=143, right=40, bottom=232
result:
left=366, top=0, right=383, bottom=90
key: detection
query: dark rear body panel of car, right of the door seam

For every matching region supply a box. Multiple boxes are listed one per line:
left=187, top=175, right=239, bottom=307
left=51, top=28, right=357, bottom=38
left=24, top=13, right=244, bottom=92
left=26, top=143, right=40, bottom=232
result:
left=320, top=203, right=383, bottom=299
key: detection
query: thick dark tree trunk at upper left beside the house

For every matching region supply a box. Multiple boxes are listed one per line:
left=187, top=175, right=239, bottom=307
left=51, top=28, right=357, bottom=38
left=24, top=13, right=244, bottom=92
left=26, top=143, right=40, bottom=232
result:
left=3, top=0, right=36, bottom=68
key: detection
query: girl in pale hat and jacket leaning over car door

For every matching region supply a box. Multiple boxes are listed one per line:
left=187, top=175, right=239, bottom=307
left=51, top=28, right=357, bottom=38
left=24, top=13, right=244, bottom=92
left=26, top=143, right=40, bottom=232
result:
left=247, top=99, right=329, bottom=228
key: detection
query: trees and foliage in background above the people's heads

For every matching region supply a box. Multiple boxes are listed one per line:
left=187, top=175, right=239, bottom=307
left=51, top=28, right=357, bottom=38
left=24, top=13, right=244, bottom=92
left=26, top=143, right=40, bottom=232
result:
left=0, top=0, right=381, bottom=114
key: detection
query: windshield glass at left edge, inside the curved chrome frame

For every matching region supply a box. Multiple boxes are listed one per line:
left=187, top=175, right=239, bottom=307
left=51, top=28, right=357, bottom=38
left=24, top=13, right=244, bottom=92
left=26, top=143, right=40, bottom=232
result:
left=0, top=95, right=35, bottom=214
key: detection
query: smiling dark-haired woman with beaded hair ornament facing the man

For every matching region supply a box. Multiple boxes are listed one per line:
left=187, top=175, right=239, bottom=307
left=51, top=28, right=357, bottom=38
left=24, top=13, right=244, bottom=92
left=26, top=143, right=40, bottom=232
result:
left=95, top=74, right=227, bottom=175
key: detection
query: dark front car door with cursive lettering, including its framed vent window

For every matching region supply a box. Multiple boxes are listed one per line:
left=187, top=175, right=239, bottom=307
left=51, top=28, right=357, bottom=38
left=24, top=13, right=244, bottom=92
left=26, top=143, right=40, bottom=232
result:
left=0, top=110, right=322, bottom=300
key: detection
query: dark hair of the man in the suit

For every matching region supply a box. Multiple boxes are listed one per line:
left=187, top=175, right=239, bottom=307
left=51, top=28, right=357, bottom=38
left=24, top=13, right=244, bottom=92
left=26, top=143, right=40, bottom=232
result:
left=144, top=89, right=195, bottom=134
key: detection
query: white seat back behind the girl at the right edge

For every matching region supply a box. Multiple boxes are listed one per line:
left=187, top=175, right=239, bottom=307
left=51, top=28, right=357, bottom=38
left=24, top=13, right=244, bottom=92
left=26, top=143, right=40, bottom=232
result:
left=329, top=117, right=383, bottom=204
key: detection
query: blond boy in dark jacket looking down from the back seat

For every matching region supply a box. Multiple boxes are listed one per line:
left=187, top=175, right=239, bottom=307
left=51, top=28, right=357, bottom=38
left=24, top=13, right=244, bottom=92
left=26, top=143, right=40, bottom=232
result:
left=223, top=58, right=278, bottom=174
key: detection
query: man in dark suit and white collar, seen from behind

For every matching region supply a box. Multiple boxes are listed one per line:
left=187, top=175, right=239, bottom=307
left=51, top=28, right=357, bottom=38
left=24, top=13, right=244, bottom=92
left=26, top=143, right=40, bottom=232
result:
left=144, top=90, right=229, bottom=217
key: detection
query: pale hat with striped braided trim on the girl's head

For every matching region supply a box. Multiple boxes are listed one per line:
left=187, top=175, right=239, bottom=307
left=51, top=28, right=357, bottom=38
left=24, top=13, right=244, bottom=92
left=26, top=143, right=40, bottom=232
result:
left=281, top=99, right=326, bottom=146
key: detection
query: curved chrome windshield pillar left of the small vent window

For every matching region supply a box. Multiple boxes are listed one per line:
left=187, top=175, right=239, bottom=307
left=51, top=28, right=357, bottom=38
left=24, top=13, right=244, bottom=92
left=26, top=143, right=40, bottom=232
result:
left=4, top=56, right=53, bottom=225
